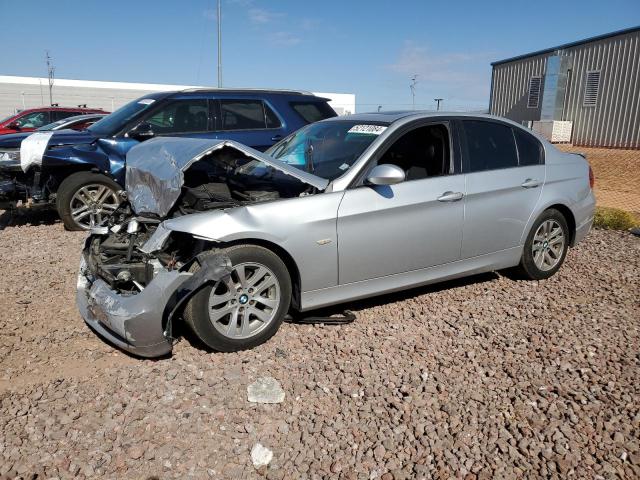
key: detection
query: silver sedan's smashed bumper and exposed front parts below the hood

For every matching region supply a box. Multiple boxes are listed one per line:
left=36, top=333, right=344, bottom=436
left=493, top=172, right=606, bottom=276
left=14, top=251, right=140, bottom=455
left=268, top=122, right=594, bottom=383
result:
left=76, top=217, right=231, bottom=357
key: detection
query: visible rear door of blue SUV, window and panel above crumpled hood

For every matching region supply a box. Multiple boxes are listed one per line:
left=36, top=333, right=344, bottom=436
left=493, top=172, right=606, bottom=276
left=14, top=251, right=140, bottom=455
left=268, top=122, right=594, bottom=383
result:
left=215, top=97, right=287, bottom=152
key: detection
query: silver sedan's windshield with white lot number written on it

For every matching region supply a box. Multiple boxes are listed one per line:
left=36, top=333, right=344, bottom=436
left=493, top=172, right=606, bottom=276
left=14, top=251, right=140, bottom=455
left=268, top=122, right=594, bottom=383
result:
left=265, top=120, right=387, bottom=180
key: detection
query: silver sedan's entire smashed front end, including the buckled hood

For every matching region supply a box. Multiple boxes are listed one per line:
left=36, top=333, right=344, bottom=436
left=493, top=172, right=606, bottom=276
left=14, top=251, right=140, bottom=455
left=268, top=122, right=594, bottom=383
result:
left=76, top=138, right=326, bottom=357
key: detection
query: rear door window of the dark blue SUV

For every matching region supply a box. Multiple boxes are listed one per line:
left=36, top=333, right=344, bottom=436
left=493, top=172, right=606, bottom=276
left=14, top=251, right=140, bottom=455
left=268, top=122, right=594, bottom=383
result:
left=220, top=100, right=280, bottom=130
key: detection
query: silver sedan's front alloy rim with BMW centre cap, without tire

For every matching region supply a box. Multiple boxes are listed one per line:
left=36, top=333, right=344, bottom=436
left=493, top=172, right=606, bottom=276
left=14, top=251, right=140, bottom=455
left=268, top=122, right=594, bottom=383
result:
left=209, top=263, right=280, bottom=339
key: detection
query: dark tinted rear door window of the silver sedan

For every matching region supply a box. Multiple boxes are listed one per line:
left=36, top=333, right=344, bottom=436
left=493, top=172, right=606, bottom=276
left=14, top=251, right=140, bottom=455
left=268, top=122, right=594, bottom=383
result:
left=462, top=120, right=518, bottom=172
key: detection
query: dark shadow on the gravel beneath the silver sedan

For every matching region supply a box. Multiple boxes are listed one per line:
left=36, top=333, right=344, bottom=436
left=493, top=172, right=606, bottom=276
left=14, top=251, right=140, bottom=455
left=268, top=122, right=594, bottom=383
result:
left=179, top=272, right=500, bottom=353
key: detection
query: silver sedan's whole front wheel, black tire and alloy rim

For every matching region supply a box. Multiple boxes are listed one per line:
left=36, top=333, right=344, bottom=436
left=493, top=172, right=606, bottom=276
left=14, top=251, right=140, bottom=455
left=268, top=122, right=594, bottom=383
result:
left=184, top=244, right=291, bottom=352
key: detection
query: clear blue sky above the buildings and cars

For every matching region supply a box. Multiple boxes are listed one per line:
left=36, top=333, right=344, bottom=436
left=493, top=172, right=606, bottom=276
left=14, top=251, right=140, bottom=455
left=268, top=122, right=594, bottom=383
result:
left=0, top=0, right=640, bottom=111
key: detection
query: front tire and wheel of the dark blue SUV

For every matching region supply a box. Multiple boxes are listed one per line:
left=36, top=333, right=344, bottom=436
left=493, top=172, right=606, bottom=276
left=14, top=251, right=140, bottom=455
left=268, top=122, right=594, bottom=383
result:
left=56, top=172, right=122, bottom=230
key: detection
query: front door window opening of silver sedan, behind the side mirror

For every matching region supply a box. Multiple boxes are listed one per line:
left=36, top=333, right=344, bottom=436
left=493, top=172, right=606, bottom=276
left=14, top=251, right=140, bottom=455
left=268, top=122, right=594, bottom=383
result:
left=378, top=124, right=451, bottom=181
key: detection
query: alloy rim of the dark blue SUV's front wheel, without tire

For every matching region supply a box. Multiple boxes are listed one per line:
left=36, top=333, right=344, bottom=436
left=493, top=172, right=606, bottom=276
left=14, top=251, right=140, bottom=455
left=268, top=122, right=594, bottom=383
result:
left=69, top=183, right=120, bottom=230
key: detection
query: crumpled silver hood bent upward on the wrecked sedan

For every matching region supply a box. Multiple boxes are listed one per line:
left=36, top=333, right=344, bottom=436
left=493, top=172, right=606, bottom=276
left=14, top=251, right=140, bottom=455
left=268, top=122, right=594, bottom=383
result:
left=125, top=137, right=329, bottom=217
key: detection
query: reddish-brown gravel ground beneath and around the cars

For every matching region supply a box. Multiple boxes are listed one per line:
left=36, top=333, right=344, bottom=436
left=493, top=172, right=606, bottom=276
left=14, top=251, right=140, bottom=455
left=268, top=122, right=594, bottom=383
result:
left=0, top=211, right=640, bottom=480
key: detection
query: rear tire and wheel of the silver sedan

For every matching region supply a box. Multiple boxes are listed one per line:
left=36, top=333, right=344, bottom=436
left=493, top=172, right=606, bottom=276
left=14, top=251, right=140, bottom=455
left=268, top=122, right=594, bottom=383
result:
left=516, top=208, right=570, bottom=280
